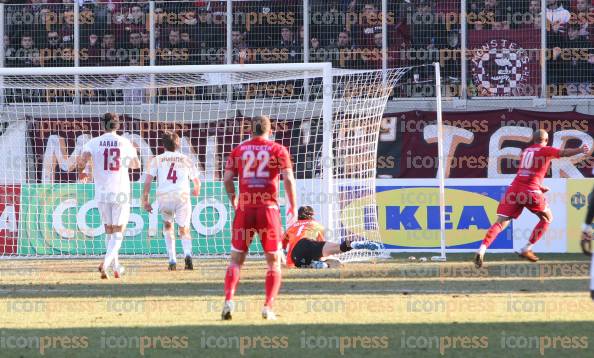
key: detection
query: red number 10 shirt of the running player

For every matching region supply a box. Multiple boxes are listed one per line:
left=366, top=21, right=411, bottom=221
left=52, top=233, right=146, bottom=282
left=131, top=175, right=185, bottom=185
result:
left=511, top=144, right=561, bottom=190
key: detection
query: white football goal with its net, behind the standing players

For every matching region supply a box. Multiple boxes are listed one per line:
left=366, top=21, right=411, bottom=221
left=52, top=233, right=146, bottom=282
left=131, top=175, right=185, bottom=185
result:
left=0, top=64, right=407, bottom=261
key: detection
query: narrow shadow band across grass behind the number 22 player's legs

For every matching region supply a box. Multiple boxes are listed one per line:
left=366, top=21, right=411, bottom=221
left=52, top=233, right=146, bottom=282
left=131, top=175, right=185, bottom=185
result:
left=0, top=278, right=588, bottom=299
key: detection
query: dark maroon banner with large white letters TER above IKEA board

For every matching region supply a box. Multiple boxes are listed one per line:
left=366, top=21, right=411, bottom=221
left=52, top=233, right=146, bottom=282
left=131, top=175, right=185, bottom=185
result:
left=377, top=110, right=594, bottom=178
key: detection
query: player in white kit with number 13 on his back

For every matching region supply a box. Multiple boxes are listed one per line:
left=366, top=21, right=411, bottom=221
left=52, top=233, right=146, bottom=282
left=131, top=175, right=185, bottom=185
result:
left=78, top=113, right=140, bottom=279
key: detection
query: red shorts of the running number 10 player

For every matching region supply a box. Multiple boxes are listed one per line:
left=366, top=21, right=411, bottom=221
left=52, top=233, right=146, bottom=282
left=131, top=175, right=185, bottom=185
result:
left=497, top=186, right=548, bottom=219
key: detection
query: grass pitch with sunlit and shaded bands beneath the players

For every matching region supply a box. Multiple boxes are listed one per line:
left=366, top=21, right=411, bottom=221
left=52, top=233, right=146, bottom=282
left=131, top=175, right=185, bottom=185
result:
left=0, top=254, right=594, bottom=358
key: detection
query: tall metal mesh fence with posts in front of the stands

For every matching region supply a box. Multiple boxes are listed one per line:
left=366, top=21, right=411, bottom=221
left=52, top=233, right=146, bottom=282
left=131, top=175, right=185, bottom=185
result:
left=0, top=0, right=594, bottom=99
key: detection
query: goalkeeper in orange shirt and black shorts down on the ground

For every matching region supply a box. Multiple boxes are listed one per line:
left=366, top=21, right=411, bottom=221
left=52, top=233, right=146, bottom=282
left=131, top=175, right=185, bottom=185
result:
left=283, top=206, right=380, bottom=267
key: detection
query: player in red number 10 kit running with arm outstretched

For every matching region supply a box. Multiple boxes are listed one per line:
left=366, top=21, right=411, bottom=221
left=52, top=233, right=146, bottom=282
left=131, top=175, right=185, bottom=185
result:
left=474, top=129, right=590, bottom=268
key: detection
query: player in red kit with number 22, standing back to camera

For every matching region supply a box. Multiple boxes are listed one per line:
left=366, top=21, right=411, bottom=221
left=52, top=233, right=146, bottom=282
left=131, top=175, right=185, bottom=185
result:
left=221, top=116, right=296, bottom=320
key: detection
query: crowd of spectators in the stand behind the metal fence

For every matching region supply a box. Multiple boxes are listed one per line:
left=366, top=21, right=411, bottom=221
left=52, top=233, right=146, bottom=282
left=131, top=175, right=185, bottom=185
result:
left=4, top=0, right=594, bottom=94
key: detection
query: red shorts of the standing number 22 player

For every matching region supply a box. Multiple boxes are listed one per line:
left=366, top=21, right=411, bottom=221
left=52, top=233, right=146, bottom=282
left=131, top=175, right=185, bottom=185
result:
left=231, top=206, right=282, bottom=252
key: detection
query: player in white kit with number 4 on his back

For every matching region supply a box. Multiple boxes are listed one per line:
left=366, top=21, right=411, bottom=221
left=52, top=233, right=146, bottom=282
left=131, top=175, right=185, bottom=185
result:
left=142, top=132, right=200, bottom=271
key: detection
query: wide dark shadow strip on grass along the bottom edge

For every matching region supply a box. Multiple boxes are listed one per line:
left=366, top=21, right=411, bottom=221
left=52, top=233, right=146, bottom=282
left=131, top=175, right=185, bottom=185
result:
left=0, top=324, right=594, bottom=358
